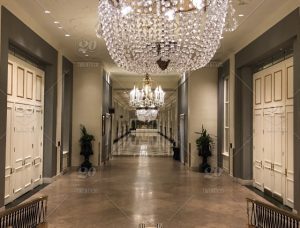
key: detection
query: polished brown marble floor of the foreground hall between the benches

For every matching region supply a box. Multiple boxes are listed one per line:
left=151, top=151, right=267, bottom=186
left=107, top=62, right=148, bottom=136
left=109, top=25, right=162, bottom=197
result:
left=27, top=134, right=268, bottom=228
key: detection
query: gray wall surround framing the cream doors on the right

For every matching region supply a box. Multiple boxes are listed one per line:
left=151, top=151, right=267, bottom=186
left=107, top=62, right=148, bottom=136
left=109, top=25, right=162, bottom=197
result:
left=233, top=8, right=300, bottom=212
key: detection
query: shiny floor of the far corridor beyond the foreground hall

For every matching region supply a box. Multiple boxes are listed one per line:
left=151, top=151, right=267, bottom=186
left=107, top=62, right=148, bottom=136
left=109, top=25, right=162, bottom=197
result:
left=112, top=132, right=173, bottom=156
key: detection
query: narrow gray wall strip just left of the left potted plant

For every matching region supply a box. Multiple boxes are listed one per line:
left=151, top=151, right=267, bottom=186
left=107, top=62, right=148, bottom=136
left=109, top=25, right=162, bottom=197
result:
left=60, top=57, right=73, bottom=170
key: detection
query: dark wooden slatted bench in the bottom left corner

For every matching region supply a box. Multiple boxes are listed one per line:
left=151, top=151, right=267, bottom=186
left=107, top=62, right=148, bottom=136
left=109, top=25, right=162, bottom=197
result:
left=0, top=196, right=48, bottom=228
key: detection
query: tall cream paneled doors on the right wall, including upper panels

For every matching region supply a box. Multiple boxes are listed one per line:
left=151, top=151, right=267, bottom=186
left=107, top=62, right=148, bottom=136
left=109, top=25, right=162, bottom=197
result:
left=253, top=58, right=294, bottom=208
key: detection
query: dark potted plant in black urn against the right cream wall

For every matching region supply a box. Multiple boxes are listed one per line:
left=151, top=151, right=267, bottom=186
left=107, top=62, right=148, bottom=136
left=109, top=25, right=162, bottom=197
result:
left=196, top=125, right=213, bottom=173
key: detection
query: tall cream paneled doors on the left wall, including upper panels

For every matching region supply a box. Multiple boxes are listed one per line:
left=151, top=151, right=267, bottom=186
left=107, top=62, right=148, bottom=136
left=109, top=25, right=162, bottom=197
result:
left=4, top=56, right=44, bottom=204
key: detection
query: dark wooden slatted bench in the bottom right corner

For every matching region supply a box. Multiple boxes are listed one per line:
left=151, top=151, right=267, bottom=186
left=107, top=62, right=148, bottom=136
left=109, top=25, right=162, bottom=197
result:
left=247, top=198, right=300, bottom=228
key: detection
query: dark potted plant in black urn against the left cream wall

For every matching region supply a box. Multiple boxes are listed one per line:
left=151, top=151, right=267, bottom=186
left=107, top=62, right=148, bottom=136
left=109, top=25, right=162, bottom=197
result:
left=79, top=125, right=95, bottom=169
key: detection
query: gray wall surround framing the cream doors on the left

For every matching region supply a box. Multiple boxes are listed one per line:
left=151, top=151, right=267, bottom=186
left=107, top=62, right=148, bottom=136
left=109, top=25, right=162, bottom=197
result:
left=0, top=6, right=57, bottom=207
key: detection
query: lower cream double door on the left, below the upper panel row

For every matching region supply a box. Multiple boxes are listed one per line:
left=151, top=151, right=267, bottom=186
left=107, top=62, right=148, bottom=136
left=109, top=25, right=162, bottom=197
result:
left=5, top=103, right=43, bottom=204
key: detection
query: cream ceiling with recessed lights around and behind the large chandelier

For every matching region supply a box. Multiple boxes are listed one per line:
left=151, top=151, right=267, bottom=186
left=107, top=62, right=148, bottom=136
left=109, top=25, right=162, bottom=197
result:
left=7, top=0, right=300, bottom=108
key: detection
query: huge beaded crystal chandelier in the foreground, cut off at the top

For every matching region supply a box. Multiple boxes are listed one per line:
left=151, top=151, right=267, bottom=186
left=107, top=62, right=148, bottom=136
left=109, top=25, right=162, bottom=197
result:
left=97, top=0, right=231, bottom=73
